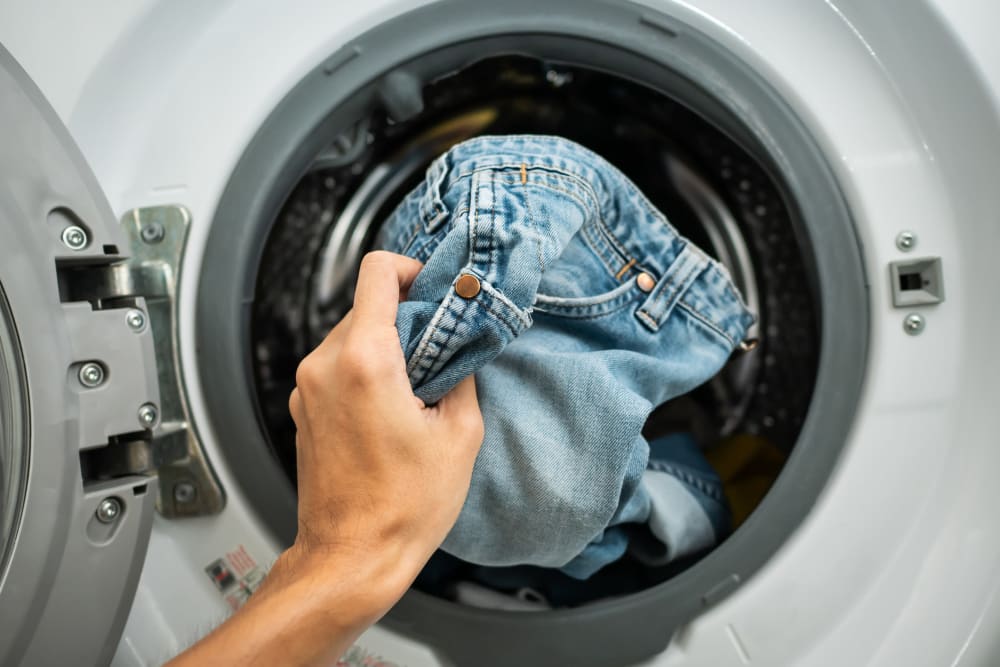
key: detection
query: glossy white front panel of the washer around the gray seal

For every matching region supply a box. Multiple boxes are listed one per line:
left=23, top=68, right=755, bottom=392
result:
left=7, top=0, right=1000, bottom=667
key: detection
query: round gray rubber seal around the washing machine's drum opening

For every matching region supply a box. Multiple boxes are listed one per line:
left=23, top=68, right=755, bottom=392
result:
left=197, top=0, right=869, bottom=667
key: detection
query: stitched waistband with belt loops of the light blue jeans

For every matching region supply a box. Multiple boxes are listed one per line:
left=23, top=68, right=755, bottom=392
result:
left=410, top=135, right=746, bottom=344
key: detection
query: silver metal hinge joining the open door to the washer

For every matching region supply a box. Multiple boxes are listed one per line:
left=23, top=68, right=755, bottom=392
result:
left=57, top=206, right=225, bottom=518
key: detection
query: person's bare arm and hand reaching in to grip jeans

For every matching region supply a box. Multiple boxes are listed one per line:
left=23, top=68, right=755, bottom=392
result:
left=170, top=252, right=483, bottom=667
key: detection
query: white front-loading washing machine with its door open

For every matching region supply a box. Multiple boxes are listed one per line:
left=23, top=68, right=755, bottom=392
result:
left=0, top=0, right=1000, bottom=667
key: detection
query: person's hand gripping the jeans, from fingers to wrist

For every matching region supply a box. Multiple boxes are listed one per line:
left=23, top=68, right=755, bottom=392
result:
left=289, top=252, right=483, bottom=604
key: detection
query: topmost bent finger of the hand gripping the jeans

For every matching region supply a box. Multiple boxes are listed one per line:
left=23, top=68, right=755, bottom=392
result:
left=354, top=251, right=423, bottom=327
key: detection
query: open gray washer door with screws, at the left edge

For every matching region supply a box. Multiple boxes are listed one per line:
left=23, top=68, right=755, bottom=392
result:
left=0, top=48, right=159, bottom=665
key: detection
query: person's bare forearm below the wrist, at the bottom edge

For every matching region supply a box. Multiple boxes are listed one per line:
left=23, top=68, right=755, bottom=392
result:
left=169, top=547, right=415, bottom=667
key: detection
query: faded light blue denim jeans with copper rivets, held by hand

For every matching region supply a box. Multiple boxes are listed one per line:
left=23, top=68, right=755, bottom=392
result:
left=380, top=136, right=753, bottom=579
